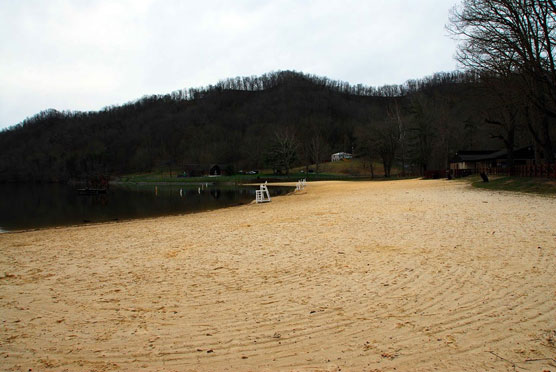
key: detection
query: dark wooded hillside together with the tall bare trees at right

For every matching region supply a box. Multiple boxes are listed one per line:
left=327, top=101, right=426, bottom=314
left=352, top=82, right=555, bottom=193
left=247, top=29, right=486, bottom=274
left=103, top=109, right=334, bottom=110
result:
left=0, top=0, right=556, bottom=182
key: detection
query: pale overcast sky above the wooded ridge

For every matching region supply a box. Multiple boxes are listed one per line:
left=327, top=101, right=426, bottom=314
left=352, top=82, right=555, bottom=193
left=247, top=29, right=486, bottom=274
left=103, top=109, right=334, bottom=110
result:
left=0, top=0, right=458, bottom=128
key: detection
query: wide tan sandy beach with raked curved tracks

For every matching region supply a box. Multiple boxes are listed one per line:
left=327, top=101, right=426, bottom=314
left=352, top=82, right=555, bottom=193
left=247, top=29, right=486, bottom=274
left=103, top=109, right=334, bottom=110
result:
left=0, top=180, right=556, bottom=371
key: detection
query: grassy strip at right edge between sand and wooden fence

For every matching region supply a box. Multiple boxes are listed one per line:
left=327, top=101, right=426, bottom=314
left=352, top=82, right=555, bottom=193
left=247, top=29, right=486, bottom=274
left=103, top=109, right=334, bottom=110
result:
left=466, top=176, right=556, bottom=195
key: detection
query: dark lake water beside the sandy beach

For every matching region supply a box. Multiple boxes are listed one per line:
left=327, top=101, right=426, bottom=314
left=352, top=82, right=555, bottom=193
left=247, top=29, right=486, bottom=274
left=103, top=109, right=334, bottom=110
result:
left=0, top=185, right=293, bottom=232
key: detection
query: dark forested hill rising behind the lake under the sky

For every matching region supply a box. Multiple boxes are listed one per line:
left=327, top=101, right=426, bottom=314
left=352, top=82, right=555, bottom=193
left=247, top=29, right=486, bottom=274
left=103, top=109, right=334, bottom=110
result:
left=0, top=71, right=540, bottom=182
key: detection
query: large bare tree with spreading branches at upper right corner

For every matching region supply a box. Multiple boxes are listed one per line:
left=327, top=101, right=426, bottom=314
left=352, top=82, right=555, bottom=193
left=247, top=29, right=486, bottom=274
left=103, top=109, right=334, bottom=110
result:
left=447, top=0, right=556, bottom=162
